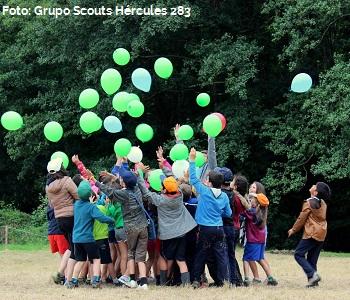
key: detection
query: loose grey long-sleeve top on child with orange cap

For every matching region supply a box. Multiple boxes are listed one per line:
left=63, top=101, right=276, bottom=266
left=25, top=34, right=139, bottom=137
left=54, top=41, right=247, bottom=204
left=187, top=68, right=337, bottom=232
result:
left=139, top=181, right=197, bottom=240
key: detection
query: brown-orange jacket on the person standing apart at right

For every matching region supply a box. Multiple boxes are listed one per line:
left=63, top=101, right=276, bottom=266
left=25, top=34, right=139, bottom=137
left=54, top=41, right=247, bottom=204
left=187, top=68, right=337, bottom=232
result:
left=292, top=198, right=327, bottom=242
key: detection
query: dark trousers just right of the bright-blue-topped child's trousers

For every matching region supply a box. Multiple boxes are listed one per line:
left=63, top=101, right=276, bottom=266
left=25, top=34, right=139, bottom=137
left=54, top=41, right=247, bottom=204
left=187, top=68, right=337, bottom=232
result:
left=224, top=226, right=242, bottom=285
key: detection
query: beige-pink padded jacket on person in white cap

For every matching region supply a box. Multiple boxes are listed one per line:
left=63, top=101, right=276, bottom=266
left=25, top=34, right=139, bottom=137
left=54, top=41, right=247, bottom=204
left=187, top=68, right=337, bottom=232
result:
left=45, top=176, right=79, bottom=218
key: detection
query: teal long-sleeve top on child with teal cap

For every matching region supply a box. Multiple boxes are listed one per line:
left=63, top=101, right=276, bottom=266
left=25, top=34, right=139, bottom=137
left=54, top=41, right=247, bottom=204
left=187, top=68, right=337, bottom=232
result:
left=73, top=200, right=114, bottom=243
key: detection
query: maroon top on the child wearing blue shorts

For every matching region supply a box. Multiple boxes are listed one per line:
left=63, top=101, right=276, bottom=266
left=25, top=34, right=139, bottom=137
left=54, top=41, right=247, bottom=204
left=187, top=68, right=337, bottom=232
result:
left=242, top=208, right=266, bottom=244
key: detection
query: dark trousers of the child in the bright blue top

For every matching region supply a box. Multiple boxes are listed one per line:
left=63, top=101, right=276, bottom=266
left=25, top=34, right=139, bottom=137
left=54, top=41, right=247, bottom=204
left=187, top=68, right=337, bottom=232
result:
left=194, top=225, right=228, bottom=284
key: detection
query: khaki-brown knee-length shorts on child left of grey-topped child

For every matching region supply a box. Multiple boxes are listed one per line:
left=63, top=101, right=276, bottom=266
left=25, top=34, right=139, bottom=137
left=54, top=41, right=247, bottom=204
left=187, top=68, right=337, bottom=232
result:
left=126, top=226, right=148, bottom=262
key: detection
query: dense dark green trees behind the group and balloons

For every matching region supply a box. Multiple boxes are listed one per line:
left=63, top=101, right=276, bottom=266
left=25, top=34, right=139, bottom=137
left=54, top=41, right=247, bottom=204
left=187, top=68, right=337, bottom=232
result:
left=0, top=0, right=350, bottom=250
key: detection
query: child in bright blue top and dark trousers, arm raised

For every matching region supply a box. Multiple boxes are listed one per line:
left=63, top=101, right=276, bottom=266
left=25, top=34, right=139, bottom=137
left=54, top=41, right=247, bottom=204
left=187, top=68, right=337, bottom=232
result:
left=190, top=148, right=232, bottom=288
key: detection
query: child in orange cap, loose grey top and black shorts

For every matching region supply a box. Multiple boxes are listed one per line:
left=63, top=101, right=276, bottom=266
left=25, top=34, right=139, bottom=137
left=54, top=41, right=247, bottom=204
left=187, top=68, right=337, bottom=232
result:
left=139, top=176, right=197, bottom=285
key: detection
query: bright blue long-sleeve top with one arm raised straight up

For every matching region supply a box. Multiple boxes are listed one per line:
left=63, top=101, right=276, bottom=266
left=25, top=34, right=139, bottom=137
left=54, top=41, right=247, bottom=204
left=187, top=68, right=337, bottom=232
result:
left=190, top=161, right=232, bottom=226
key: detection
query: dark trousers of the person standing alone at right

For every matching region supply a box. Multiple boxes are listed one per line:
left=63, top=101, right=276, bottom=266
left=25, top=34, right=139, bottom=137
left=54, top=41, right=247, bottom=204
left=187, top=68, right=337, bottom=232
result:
left=294, top=239, right=323, bottom=278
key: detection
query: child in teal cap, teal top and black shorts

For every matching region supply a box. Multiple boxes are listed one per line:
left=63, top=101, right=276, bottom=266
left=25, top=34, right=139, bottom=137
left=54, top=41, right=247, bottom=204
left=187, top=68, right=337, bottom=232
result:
left=66, top=180, right=114, bottom=288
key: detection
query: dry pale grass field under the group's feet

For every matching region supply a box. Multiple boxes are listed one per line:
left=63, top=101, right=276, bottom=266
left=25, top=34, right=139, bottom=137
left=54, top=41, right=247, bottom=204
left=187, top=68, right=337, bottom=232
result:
left=0, top=246, right=350, bottom=300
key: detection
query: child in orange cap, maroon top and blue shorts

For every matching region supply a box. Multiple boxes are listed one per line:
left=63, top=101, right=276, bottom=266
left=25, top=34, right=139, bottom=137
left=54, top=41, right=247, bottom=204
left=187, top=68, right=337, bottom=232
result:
left=242, top=193, right=278, bottom=285
